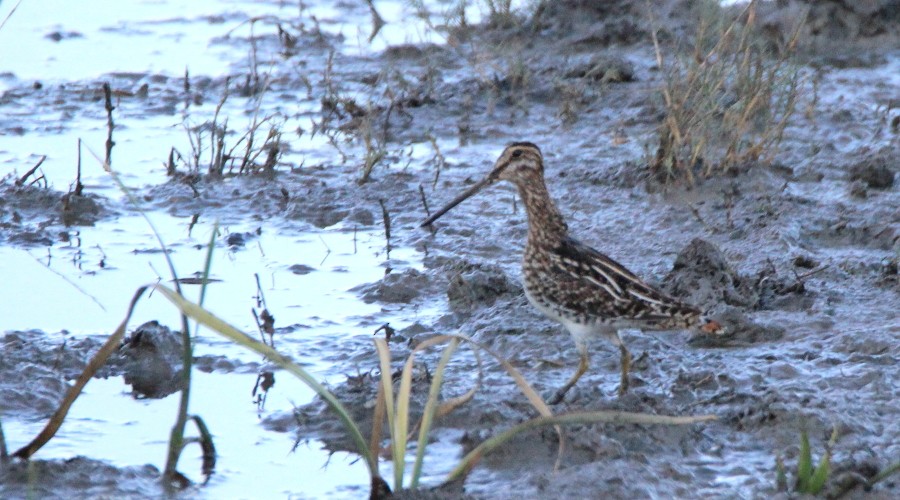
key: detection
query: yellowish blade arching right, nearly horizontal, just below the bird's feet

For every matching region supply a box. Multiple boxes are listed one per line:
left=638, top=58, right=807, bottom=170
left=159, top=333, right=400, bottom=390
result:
left=445, top=411, right=716, bottom=483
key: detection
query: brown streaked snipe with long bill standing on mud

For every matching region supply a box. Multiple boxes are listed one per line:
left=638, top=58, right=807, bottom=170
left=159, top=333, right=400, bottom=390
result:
left=422, top=142, right=722, bottom=404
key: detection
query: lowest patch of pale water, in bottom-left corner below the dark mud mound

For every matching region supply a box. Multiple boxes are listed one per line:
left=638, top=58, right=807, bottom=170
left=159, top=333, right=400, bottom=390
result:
left=3, top=371, right=369, bottom=498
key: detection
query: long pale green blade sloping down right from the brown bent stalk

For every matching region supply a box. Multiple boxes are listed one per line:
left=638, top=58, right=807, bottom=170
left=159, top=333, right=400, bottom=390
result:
left=151, top=284, right=378, bottom=477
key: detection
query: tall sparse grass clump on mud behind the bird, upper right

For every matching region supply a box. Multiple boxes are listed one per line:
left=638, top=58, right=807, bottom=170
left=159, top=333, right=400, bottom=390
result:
left=650, top=0, right=804, bottom=184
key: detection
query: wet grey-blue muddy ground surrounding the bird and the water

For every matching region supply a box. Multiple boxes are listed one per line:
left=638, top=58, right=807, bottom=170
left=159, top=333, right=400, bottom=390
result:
left=0, top=2, right=900, bottom=498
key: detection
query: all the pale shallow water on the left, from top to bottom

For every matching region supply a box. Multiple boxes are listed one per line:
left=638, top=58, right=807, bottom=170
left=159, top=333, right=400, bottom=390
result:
left=0, top=0, right=460, bottom=498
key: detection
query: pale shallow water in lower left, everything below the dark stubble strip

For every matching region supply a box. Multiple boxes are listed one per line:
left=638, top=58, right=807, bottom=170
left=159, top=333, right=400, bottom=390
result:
left=0, top=213, right=436, bottom=498
